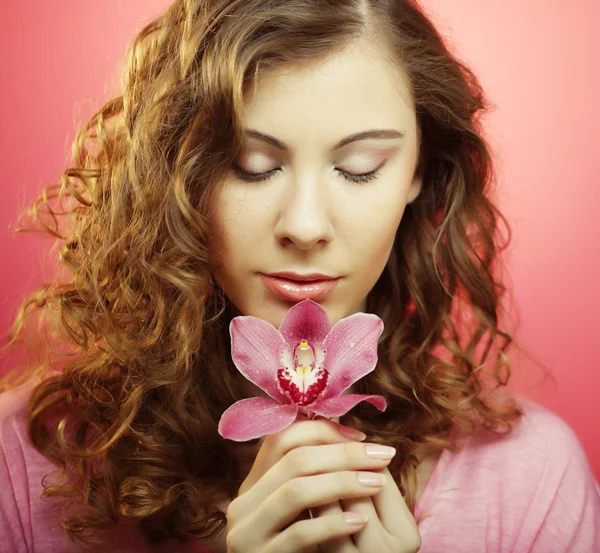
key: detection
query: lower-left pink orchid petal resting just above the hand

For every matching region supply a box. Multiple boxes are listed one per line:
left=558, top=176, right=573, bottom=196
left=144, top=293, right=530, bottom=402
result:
left=219, top=397, right=298, bottom=442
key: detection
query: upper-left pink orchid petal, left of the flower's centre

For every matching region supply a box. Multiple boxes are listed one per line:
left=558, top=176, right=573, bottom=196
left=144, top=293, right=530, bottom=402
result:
left=229, top=316, right=290, bottom=403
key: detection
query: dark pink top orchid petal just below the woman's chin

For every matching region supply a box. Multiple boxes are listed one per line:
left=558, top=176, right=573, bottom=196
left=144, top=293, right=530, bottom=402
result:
left=279, top=300, right=331, bottom=347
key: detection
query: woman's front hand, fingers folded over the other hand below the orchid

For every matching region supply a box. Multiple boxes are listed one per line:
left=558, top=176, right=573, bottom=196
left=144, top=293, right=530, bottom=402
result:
left=227, top=419, right=389, bottom=553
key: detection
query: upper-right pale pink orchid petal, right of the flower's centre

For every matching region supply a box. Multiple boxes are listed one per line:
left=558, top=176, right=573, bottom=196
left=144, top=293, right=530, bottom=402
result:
left=323, top=313, right=383, bottom=398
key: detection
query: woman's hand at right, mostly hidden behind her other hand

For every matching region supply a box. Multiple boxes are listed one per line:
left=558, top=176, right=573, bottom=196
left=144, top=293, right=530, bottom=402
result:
left=311, top=468, right=421, bottom=553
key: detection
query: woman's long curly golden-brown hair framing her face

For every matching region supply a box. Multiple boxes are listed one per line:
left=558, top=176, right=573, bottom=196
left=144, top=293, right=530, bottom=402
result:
left=5, top=0, right=521, bottom=545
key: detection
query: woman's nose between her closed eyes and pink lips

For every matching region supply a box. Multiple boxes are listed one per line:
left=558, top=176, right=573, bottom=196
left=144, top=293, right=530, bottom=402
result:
left=275, top=176, right=334, bottom=250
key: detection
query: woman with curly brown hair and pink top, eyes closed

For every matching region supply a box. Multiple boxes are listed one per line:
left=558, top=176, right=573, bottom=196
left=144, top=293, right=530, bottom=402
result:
left=0, top=0, right=600, bottom=553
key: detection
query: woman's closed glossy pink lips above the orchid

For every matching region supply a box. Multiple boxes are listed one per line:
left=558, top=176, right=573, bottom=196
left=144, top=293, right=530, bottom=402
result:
left=260, top=273, right=340, bottom=301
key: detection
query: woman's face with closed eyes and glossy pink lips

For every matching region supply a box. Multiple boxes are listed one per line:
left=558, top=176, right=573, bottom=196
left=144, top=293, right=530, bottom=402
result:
left=211, top=38, right=421, bottom=326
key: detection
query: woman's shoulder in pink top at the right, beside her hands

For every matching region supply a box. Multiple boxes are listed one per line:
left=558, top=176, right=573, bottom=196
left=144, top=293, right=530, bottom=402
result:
left=424, top=398, right=600, bottom=553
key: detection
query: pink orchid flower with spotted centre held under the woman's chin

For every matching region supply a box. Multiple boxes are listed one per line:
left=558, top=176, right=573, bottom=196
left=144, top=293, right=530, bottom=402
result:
left=219, top=300, right=387, bottom=442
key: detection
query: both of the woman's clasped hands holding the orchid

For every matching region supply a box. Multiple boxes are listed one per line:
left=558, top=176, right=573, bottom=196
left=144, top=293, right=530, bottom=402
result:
left=225, top=417, right=421, bottom=553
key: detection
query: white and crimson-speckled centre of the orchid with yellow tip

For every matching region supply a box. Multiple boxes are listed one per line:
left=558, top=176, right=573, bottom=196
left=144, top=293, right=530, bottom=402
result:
left=277, top=340, right=329, bottom=405
